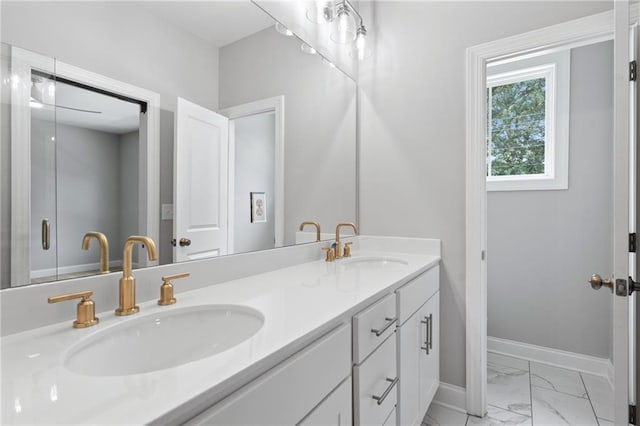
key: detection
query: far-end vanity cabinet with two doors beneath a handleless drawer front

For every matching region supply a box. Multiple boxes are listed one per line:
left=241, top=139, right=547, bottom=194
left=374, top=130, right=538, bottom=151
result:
left=396, top=266, right=440, bottom=426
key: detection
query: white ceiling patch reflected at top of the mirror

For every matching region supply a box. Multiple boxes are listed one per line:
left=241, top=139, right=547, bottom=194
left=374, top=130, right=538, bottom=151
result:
left=139, top=0, right=274, bottom=47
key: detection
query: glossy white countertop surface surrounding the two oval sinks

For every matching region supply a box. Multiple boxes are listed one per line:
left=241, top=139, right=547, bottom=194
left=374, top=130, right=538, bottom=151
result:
left=0, top=240, right=440, bottom=424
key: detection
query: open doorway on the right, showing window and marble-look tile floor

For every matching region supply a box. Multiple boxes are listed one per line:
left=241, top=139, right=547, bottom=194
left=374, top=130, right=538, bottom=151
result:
left=487, top=40, right=613, bottom=425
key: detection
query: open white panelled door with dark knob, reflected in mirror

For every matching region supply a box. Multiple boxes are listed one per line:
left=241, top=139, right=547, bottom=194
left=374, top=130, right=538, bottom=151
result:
left=173, top=98, right=229, bottom=262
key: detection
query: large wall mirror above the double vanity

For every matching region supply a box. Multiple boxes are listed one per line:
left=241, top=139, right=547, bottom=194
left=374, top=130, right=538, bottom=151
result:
left=0, top=1, right=356, bottom=288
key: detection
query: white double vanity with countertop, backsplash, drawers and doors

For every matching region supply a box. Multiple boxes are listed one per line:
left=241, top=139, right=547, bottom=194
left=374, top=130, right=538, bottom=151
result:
left=0, top=236, right=440, bottom=425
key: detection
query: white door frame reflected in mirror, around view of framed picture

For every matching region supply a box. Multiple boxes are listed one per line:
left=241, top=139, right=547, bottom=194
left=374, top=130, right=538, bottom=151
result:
left=218, top=95, right=284, bottom=253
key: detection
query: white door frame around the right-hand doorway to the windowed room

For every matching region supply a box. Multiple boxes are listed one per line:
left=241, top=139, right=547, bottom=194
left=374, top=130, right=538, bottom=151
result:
left=466, top=2, right=640, bottom=424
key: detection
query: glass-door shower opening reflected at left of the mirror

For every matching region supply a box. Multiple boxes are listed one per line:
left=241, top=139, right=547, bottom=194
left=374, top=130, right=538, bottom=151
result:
left=29, top=71, right=146, bottom=282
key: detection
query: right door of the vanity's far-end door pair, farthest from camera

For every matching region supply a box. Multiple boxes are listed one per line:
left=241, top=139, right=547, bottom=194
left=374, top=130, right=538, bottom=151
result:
left=418, top=292, right=440, bottom=415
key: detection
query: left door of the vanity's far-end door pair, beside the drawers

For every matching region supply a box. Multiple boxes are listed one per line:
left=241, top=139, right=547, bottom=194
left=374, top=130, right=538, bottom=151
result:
left=397, top=310, right=426, bottom=426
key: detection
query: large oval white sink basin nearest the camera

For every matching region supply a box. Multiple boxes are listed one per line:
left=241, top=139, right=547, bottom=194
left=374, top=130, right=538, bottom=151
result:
left=64, top=305, right=264, bottom=376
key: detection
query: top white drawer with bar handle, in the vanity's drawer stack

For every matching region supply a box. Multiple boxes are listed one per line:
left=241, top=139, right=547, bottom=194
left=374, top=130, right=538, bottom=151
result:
left=353, top=294, right=396, bottom=364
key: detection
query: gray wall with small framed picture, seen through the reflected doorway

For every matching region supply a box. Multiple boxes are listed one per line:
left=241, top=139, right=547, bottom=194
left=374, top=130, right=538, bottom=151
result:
left=233, top=113, right=276, bottom=253
